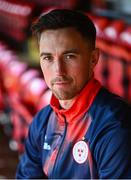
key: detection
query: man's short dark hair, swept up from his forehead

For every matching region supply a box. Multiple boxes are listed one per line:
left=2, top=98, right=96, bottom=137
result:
left=32, top=9, right=96, bottom=49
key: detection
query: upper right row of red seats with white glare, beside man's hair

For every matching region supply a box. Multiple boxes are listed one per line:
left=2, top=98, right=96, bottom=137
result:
left=90, top=15, right=131, bottom=49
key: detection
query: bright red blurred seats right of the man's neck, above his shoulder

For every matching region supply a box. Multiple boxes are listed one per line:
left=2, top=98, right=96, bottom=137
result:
left=95, top=39, right=131, bottom=102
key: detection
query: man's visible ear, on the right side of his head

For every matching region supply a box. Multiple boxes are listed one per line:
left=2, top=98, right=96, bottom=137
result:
left=91, top=48, right=100, bottom=68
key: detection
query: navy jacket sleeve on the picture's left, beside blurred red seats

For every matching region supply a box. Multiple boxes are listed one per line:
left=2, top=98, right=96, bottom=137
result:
left=16, top=106, right=49, bottom=179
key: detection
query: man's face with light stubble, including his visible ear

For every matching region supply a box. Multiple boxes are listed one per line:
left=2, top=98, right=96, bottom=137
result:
left=39, top=28, right=98, bottom=100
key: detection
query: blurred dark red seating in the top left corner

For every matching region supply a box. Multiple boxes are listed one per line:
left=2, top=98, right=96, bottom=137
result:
left=0, top=0, right=34, bottom=42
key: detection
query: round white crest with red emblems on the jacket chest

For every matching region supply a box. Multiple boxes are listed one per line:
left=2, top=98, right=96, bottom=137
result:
left=73, top=141, right=88, bottom=164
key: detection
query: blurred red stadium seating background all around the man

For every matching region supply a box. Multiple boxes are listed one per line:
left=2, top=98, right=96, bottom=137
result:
left=0, top=0, right=131, bottom=179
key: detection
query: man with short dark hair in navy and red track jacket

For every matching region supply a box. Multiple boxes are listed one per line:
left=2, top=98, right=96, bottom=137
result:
left=16, top=9, right=131, bottom=179
